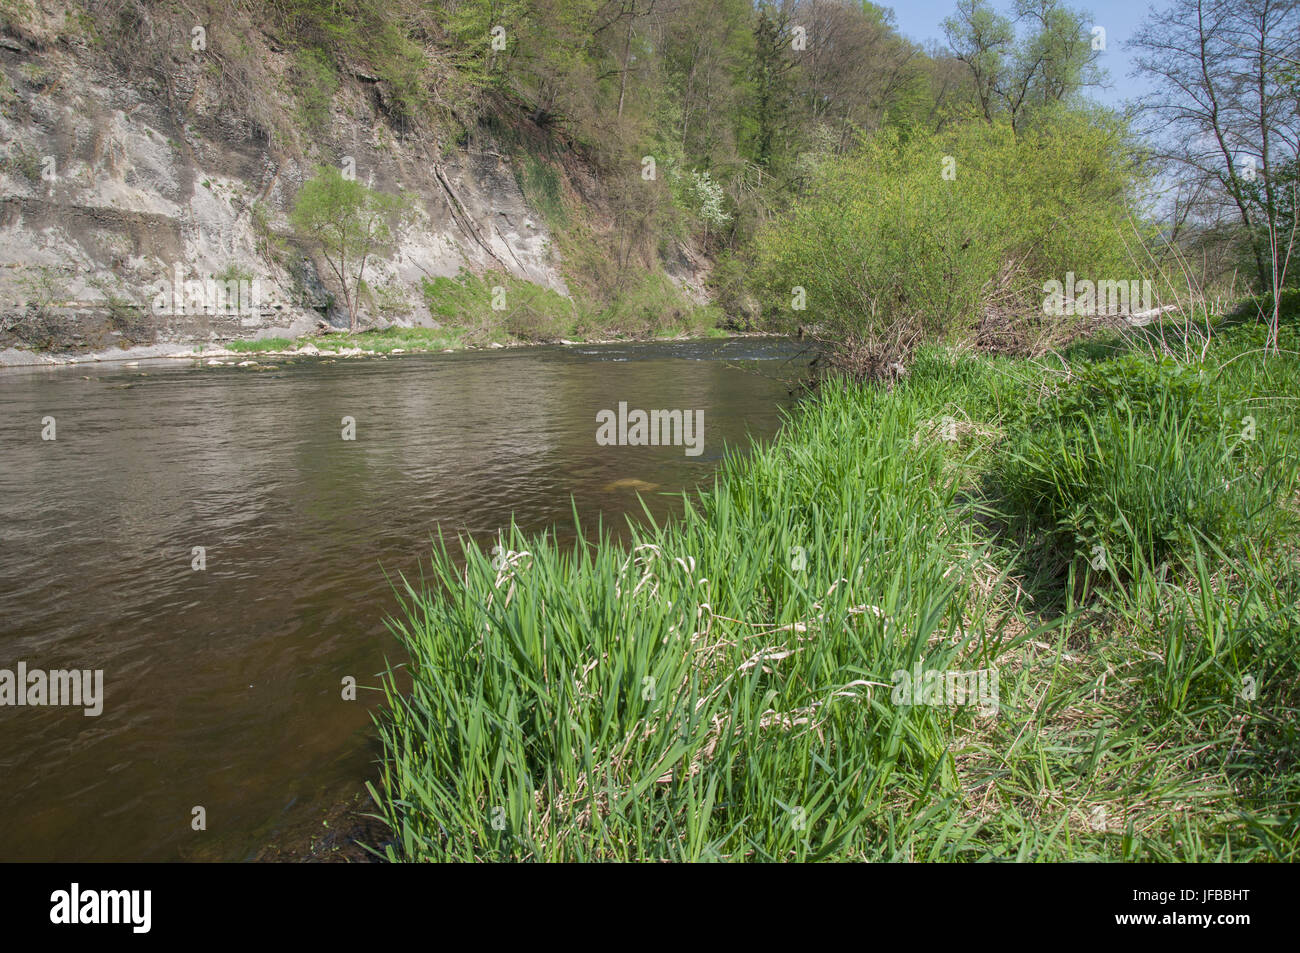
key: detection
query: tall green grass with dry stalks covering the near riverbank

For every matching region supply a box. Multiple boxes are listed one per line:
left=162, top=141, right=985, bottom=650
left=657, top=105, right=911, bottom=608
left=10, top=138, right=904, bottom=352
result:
left=372, top=321, right=1300, bottom=861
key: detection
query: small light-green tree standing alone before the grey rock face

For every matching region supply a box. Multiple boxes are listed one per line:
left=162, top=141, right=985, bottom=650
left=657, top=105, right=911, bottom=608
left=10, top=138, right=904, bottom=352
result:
left=290, top=165, right=406, bottom=332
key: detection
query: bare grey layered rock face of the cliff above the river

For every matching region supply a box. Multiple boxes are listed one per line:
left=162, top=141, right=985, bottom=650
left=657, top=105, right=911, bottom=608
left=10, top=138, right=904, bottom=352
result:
left=0, top=4, right=567, bottom=350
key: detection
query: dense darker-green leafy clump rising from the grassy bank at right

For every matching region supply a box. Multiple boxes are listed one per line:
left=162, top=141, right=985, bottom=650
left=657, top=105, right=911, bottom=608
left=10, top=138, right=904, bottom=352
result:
left=997, top=356, right=1277, bottom=579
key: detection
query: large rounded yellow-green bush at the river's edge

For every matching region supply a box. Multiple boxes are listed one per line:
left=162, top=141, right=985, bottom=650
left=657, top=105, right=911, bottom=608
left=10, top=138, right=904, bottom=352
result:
left=755, top=113, right=1138, bottom=374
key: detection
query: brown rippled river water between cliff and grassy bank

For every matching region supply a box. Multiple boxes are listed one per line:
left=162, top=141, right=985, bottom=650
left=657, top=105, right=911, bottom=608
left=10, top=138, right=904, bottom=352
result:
left=0, top=339, right=803, bottom=861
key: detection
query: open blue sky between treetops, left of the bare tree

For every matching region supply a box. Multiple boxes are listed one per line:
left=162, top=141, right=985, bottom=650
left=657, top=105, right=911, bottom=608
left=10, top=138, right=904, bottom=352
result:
left=876, top=0, right=1151, bottom=107
